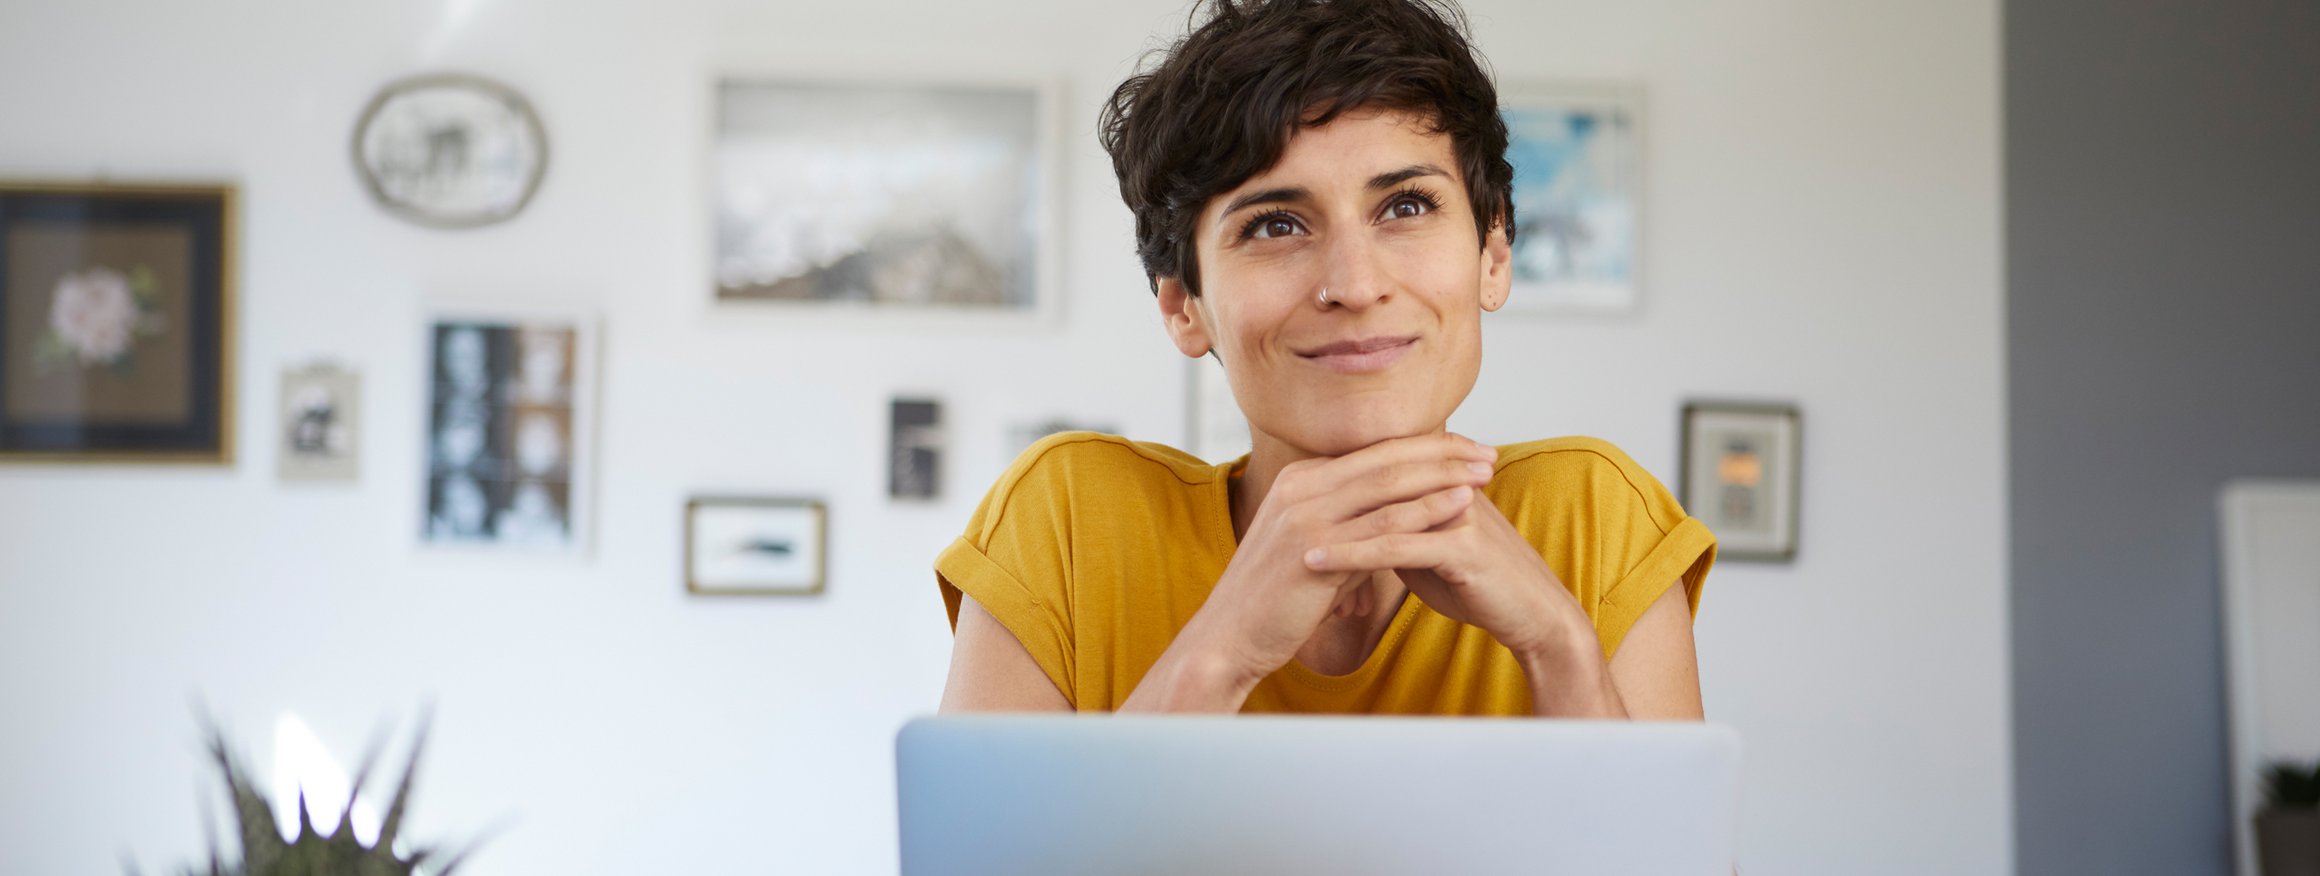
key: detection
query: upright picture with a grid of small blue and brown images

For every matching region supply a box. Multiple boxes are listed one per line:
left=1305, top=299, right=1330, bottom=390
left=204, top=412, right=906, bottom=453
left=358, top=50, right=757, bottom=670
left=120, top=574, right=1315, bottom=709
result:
left=420, top=311, right=596, bottom=549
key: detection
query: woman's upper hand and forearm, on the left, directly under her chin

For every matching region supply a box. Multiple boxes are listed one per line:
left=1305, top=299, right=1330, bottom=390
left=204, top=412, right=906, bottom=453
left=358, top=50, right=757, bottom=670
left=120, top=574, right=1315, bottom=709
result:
left=1123, top=436, right=1484, bottom=711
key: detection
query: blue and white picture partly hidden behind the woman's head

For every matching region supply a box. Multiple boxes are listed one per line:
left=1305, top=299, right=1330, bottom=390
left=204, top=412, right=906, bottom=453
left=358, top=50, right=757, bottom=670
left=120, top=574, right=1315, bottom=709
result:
left=1499, top=83, right=1643, bottom=315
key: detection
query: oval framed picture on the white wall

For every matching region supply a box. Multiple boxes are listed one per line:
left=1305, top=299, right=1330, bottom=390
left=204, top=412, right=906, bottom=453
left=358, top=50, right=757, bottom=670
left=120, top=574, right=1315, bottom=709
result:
left=355, top=74, right=548, bottom=227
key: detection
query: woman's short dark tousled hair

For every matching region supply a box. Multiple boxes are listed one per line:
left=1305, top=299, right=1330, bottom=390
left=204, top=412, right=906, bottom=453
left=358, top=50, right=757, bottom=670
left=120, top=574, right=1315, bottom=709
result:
left=1097, top=0, right=1515, bottom=297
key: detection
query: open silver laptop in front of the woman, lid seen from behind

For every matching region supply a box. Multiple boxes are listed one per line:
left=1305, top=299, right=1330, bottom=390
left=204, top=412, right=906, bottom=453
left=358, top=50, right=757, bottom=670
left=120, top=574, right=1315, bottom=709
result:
left=896, top=714, right=1740, bottom=876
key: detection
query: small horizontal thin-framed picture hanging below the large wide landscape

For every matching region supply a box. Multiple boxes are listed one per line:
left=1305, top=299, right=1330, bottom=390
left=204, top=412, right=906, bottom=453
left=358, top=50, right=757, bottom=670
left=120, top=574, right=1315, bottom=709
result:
left=684, top=498, right=831, bottom=596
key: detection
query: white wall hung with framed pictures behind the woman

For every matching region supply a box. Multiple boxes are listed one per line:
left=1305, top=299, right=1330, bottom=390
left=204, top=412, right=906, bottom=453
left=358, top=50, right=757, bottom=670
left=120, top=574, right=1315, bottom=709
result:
left=0, top=0, right=2011, bottom=874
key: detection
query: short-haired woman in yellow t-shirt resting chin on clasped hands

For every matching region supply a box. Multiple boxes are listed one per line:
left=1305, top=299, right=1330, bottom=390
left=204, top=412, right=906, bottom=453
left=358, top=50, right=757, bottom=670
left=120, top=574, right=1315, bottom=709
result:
left=935, top=0, right=1714, bottom=718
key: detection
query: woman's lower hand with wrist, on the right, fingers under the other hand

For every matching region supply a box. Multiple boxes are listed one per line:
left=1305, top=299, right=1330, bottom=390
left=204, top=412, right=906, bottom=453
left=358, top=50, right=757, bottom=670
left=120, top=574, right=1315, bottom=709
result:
left=1306, top=454, right=1601, bottom=665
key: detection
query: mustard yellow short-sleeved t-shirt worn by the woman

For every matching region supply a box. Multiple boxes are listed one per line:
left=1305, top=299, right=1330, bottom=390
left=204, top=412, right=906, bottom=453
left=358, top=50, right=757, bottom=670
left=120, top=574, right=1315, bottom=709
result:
left=935, top=431, right=1714, bottom=714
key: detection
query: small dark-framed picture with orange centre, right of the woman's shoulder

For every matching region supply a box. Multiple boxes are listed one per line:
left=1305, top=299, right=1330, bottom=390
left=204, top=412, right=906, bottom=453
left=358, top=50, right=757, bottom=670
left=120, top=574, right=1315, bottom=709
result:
left=1682, top=401, right=1803, bottom=563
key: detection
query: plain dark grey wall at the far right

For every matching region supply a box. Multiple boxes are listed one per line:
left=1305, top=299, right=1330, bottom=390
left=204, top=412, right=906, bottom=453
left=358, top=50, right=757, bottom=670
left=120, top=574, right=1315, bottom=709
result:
left=2004, top=0, right=2320, bottom=874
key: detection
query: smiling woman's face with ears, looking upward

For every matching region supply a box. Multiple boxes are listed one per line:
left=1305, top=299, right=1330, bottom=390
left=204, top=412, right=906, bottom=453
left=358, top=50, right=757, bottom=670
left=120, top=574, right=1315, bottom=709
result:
left=1160, top=111, right=1510, bottom=457
